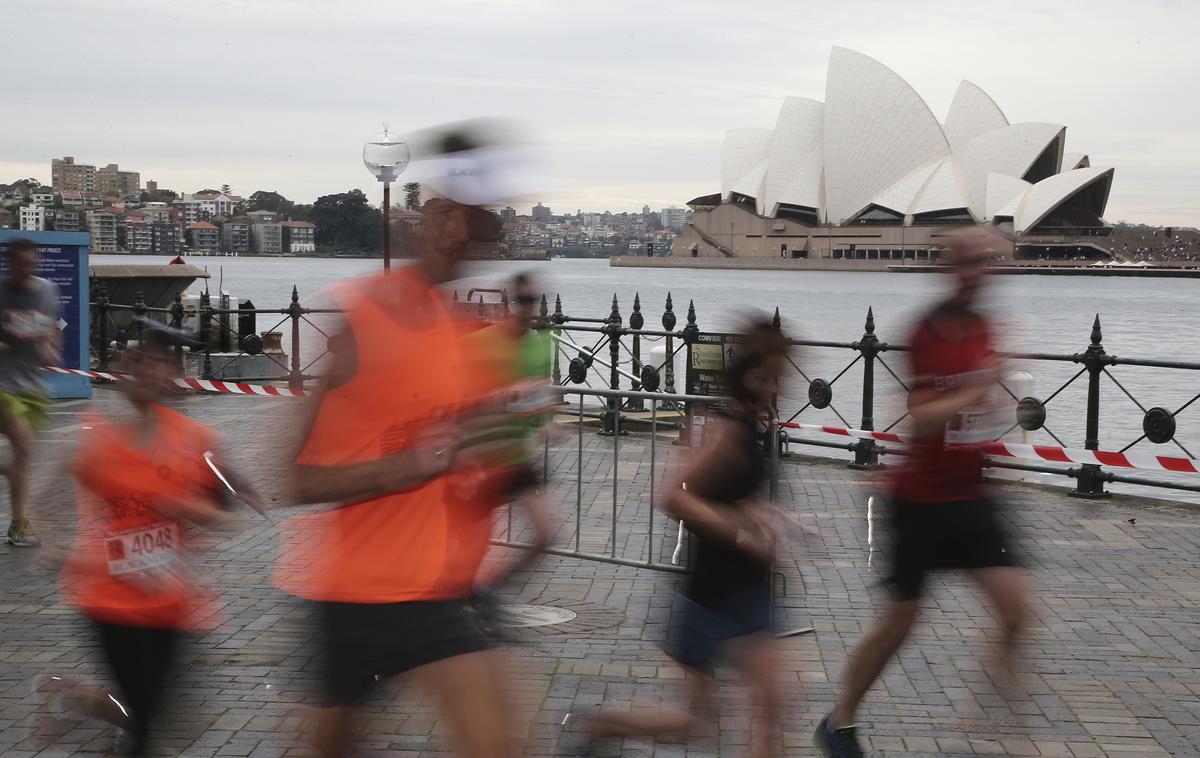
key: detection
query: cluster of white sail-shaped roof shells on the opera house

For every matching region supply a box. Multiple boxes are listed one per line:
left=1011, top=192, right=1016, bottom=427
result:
left=700, top=48, right=1106, bottom=229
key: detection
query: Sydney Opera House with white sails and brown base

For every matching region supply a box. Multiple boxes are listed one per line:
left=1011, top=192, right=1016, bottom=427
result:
left=672, top=48, right=1112, bottom=265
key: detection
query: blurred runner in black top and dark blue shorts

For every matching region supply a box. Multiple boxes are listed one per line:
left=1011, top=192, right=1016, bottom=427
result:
left=568, top=319, right=788, bottom=758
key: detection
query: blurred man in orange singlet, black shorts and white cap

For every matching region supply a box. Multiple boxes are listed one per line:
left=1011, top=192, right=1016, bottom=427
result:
left=276, top=119, right=532, bottom=757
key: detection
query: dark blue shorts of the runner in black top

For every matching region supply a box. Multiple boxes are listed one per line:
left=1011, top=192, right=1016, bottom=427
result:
left=667, top=584, right=770, bottom=673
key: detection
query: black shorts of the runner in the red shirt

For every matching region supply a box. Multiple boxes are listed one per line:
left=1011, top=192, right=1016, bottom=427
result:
left=888, top=498, right=1016, bottom=600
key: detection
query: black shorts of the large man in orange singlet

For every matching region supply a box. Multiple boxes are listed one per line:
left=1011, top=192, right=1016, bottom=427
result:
left=319, top=600, right=488, bottom=705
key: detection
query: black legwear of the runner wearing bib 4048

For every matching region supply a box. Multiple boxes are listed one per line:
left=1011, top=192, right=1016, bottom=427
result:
left=94, top=621, right=179, bottom=756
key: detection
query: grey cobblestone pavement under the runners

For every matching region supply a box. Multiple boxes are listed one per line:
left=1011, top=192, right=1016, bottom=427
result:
left=0, top=389, right=1200, bottom=758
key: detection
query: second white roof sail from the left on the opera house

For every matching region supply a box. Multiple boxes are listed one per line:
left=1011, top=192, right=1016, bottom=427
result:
left=758, top=97, right=824, bottom=216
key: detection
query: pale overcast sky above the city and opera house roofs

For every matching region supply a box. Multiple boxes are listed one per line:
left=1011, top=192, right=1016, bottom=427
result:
left=0, top=0, right=1200, bottom=225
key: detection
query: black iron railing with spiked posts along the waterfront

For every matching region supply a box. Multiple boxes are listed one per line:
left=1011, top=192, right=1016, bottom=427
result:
left=91, top=285, right=1200, bottom=498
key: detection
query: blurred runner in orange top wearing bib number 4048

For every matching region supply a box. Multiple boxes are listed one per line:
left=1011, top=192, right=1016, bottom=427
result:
left=40, top=325, right=231, bottom=756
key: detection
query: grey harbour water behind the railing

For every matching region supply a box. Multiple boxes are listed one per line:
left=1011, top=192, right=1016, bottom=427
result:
left=92, top=255, right=1200, bottom=499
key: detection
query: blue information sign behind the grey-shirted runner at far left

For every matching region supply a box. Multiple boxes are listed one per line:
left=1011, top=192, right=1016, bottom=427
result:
left=0, top=229, right=91, bottom=398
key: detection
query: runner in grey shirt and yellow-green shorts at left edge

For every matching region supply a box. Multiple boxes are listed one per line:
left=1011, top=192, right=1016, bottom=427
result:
left=0, top=239, right=59, bottom=547
